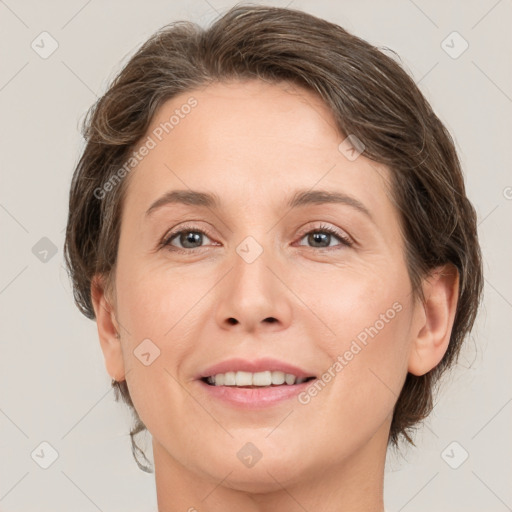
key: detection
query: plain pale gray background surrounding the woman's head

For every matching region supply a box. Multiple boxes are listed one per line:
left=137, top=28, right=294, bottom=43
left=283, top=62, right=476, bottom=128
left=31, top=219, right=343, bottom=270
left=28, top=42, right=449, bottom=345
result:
left=0, top=0, right=512, bottom=512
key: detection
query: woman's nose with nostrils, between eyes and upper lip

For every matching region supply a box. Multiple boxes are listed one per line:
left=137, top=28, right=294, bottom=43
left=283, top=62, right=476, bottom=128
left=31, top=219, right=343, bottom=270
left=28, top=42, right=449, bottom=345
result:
left=212, top=242, right=293, bottom=333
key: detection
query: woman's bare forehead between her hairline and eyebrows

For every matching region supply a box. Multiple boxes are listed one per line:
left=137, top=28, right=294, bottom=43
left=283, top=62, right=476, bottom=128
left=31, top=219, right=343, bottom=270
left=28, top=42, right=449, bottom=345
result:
left=121, top=80, right=391, bottom=228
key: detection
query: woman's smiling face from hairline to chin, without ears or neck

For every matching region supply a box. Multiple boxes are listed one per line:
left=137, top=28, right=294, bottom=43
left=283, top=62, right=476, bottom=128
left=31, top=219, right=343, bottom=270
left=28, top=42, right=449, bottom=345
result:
left=100, top=81, right=424, bottom=491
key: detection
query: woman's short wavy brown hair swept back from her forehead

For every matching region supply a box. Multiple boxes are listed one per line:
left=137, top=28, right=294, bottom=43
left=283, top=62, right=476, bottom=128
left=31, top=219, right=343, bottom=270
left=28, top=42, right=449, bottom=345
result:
left=64, top=5, right=483, bottom=471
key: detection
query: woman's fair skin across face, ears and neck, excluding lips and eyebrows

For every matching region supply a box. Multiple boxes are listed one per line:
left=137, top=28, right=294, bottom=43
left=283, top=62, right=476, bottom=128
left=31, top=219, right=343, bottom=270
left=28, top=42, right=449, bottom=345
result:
left=92, top=80, right=458, bottom=512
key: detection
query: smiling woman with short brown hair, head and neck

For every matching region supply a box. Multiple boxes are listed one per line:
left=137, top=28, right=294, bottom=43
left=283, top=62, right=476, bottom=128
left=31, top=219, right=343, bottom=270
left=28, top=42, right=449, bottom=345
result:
left=66, top=6, right=482, bottom=511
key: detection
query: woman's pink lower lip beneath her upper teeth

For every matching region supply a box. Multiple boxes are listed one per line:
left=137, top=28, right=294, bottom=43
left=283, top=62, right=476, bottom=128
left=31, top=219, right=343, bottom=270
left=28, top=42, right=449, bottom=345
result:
left=198, top=380, right=314, bottom=409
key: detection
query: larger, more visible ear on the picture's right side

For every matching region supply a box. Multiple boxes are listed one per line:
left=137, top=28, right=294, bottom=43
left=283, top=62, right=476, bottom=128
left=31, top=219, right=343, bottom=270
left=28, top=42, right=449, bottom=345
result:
left=408, top=264, right=459, bottom=376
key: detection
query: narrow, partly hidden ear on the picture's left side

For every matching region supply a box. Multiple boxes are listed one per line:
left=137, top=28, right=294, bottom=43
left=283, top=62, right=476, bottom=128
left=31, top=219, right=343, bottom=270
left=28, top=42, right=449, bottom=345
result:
left=91, top=275, right=125, bottom=381
